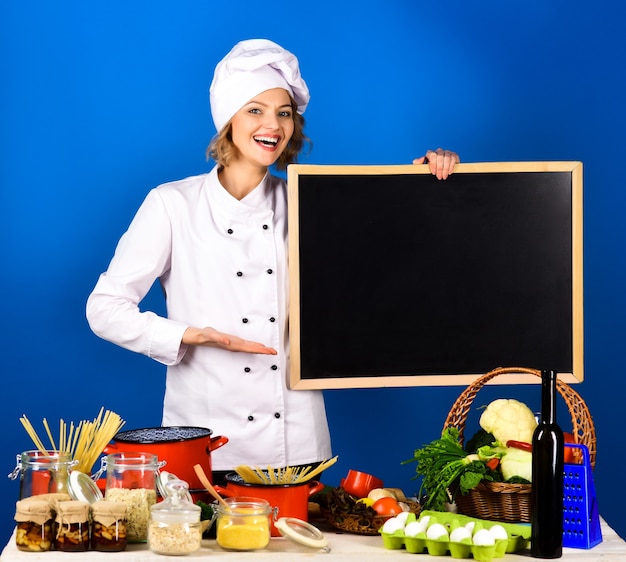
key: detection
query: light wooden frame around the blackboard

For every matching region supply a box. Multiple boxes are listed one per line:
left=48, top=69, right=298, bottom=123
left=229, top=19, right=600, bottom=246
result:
left=287, top=162, right=584, bottom=390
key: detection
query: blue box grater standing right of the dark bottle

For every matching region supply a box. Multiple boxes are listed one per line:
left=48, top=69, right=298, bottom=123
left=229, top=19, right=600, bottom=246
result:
left=563, top=443, right=602, bottom=549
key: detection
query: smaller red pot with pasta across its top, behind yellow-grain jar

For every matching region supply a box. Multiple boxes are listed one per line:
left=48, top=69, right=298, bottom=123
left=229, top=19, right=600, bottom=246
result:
left=215, top=472, right=324, bottom=537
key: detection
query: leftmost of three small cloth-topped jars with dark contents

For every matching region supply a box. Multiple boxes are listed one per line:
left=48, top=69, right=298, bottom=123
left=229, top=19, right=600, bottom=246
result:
left=15, top=500, right=53, bottom=552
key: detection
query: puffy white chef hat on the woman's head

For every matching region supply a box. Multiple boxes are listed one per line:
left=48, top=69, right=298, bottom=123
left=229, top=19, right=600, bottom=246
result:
left=209, top=39, right=309, bottom=131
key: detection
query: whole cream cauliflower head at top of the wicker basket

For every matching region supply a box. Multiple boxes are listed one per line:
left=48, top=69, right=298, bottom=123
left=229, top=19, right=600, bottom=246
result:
left=479, top=398, right=537, bottom=446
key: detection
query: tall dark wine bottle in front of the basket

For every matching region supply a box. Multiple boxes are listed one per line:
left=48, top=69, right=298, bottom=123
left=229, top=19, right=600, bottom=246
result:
left=530, top=370, right=564, bottom=558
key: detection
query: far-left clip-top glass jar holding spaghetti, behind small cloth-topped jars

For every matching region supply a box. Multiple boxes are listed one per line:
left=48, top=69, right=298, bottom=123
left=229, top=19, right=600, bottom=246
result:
left=9, top=450, right=77, bottom=499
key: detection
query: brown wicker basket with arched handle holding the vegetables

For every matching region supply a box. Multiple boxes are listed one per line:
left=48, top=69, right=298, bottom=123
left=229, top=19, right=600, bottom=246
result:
left=444, top=367, right=596, bottom=523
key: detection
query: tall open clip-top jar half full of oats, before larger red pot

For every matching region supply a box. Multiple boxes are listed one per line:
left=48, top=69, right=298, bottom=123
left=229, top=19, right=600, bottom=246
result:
left=103, top=453, right=165, bottom=542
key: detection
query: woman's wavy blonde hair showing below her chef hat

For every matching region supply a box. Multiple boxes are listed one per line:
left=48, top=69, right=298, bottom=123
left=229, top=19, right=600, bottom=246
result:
left=206, top=96, right=311, bottom=170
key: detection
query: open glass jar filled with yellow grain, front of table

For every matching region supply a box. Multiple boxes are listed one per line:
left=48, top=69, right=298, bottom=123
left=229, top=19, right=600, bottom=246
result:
left=216, top=497, right=276, bottom=550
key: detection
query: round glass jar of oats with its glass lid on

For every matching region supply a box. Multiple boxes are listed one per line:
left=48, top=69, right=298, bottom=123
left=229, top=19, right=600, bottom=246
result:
left=148, top=480, right=202, bottom=556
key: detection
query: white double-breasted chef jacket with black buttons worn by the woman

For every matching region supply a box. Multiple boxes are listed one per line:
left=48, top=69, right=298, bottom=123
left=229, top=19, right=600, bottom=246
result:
left=87, top=167, right=331, bottom=470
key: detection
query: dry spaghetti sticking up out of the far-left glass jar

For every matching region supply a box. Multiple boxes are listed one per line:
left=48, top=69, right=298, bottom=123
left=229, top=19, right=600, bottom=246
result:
left=20, top=408, right=125, bottom=473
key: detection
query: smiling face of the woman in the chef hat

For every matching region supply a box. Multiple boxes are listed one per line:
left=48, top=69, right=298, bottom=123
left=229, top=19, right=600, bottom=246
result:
left=231, top=88, right=294, bottom=168
